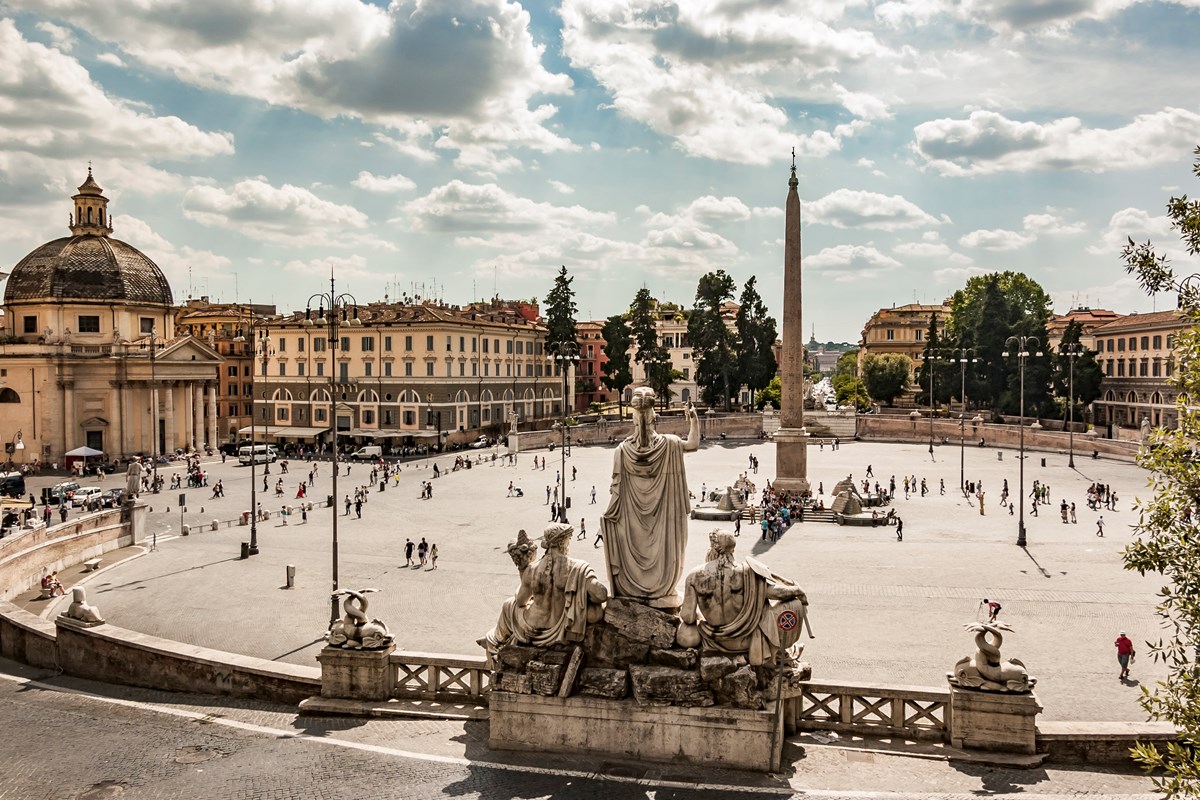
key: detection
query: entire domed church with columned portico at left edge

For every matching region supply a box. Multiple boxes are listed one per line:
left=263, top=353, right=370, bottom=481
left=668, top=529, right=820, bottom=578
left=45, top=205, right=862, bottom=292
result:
left=0, top=172, right=223, bottom=467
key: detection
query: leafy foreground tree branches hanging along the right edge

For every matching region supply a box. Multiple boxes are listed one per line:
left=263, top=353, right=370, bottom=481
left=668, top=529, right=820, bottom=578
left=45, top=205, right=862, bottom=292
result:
left=1121, top=148, right=1200, bottom=798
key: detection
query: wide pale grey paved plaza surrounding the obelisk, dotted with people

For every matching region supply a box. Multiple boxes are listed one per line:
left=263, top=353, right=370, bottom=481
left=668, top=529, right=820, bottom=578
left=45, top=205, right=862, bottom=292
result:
left=32, top=441, right=1163, bottom=721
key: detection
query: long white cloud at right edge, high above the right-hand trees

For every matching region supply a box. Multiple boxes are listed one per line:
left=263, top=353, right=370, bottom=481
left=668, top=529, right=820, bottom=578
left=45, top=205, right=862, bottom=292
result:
left=913, top=108, right=1200, bottom=175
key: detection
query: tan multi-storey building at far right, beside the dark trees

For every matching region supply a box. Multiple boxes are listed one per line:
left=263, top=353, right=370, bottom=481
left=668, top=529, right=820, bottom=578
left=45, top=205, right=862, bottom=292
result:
left=1092, top=311, right=1184, bottom=435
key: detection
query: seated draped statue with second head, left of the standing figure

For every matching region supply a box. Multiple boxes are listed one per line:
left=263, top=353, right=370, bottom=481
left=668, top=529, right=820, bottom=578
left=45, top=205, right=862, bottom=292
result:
left=479, top=522, right=608, bottom=663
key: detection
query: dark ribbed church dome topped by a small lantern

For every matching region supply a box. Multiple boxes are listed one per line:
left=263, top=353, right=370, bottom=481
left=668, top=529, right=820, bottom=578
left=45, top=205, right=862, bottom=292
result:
left=4, top=168, right=174, bottom=306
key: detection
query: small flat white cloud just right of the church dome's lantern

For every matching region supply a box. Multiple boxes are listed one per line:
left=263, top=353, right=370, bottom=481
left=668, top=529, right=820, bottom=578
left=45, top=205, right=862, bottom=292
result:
left=184, top=178, right=367, bottom=247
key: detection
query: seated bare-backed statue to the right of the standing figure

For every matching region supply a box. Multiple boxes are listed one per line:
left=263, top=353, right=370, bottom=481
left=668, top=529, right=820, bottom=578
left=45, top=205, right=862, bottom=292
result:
left=676, top=530, right=812, bottom=666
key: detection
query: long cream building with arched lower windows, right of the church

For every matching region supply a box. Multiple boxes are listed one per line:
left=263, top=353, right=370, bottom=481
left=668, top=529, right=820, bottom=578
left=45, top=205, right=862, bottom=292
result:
left=253, top=301, right=563, bottom=446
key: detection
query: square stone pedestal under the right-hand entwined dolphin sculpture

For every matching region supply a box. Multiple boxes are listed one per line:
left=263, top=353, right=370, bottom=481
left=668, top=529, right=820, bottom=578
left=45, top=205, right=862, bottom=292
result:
left=950, top=684, right=1042, bottom=756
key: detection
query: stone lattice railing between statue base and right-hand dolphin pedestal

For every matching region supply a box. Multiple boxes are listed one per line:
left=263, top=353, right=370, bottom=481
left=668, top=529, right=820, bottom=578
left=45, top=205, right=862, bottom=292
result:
left=785, top=681, right=950, bottom=741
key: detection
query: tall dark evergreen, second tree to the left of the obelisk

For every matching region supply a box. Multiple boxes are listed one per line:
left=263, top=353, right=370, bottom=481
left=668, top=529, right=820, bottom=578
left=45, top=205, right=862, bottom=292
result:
left=688, top=270, right=742, bottom=411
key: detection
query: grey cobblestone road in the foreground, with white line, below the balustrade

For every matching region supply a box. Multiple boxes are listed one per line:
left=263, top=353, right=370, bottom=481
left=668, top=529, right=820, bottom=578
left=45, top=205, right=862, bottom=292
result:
left=0, top=660, right=1153, bottom=800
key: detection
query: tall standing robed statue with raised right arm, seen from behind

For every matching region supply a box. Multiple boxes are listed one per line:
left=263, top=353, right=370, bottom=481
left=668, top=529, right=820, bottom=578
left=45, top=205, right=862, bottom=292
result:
left=600, top=386, right=700, bottom=609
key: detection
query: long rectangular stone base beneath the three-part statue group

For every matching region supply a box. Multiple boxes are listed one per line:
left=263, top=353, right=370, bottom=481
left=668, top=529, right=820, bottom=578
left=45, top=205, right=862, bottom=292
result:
left=487, top=690, right=784, bottom=772
